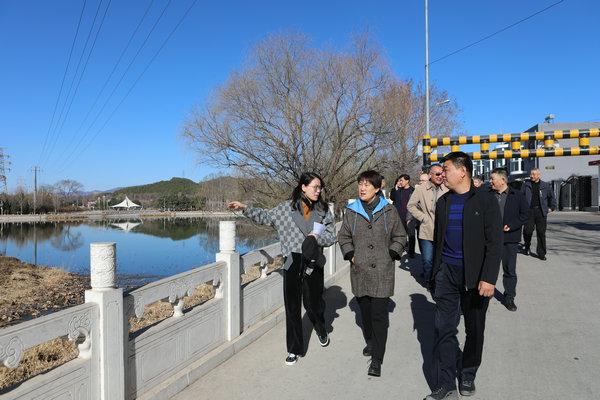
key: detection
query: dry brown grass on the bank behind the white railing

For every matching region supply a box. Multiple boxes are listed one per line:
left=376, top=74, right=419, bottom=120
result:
left=0, top=256, right=282, bottom=390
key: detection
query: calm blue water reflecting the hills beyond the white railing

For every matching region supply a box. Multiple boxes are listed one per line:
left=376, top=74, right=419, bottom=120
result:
left=0, top=218, right=278, bottom=286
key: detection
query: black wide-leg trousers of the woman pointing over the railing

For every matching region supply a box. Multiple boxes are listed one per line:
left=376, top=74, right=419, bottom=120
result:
left=283, top=253, right=327, bottom=355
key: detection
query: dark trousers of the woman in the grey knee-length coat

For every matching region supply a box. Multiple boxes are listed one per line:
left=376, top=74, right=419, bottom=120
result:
left=356, top=296, right=390, bottom=362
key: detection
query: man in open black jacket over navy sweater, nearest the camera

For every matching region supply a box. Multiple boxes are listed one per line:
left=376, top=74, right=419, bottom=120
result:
left=426, top=152, right=502, bottom=400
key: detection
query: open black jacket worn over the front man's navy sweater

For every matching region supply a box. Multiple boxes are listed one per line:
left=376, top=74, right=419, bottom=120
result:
left=432, top=185, right=503, bottom=289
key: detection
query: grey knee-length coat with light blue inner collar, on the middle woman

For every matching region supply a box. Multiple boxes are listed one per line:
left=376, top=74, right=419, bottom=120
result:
left=338, top=197, right=406, bottom=297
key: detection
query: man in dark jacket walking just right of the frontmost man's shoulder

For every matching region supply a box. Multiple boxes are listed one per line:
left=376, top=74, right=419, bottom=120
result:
left=490, top=168, right=529, bottom=311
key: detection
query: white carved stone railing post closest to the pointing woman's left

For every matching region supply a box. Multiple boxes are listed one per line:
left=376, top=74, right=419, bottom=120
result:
left=216, top=221, right=241, bottom=340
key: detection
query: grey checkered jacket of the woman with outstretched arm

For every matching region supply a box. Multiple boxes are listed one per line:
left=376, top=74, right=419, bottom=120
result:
left=244, top=200, right=335, bottom=270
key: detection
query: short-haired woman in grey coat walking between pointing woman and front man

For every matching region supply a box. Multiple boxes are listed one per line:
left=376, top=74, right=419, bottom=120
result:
left=338, top=171, right=406, bottom=376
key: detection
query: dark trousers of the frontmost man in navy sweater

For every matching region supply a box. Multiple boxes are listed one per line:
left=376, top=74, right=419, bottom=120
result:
left=432, top=263, right=490, bottom=390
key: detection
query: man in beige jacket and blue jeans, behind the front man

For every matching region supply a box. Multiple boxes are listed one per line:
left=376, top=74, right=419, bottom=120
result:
left=406, top=164, right=448, bottom=287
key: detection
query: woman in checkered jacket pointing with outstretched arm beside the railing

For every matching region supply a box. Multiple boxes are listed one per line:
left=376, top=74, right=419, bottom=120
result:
left=227, top=172, right=335, bottom=365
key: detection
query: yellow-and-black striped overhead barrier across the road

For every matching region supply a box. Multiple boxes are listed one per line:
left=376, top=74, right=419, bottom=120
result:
left=423, top=128, right=600, bottom=165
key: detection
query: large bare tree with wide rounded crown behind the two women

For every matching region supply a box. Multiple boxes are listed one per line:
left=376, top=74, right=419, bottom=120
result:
left=182, top=31, right=462, bottom=206
